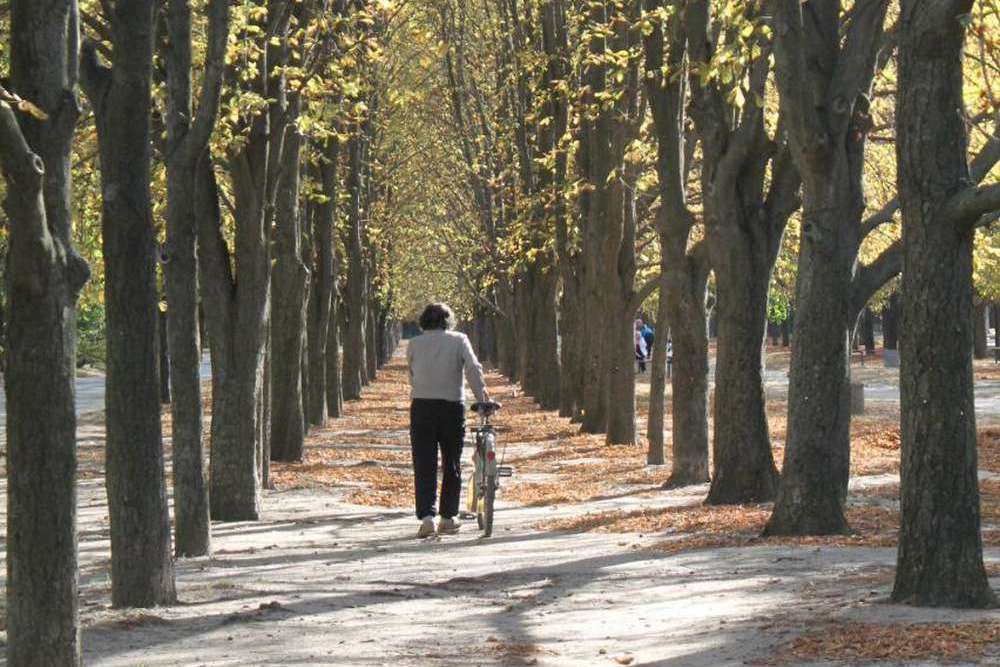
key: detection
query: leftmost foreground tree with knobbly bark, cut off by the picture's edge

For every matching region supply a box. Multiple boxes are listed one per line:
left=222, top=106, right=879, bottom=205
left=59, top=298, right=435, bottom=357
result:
left=0, top=0, right=89, bottom=665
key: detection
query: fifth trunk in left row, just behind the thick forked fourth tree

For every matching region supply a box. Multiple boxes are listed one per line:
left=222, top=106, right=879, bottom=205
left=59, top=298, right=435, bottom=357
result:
left=270, top=102, right=309, bottom=461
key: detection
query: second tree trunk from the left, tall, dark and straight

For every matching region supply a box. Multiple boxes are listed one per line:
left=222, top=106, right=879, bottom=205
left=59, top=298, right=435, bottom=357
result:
left=82, top=5, right=177, bottom=607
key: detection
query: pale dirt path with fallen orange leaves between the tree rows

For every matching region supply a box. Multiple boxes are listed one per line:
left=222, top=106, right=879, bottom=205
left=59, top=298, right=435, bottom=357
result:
left=1, top=348, right=1000, bottom=667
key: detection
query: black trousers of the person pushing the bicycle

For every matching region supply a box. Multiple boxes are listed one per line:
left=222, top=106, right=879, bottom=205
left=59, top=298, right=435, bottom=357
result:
left=410, top=398, right=465, bottom=519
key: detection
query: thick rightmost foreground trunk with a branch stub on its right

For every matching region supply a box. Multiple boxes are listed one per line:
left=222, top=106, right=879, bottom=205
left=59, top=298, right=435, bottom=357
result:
left=892, top=0, right=997, bottom=607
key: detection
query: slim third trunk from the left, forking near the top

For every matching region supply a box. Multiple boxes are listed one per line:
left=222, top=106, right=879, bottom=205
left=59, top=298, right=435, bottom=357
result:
left=164, top=0, right=229, bottom=556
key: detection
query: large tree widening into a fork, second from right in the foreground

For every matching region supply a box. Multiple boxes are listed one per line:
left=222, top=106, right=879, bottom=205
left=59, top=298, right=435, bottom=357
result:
left=767, top=0, right=888, bottom=534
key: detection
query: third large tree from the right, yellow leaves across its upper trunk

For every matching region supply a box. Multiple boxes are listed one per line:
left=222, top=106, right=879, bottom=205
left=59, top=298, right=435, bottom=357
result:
left=685, top=0, right=799, bottom=504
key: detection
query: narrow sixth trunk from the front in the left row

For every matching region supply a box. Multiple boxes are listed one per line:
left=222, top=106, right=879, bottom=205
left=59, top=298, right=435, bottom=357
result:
left=308, top=139, right=340, bottom=426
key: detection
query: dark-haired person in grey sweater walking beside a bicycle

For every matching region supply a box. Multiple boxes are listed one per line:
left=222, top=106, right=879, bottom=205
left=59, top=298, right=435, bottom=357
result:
left=406, top=303, right=489, bottom=537
